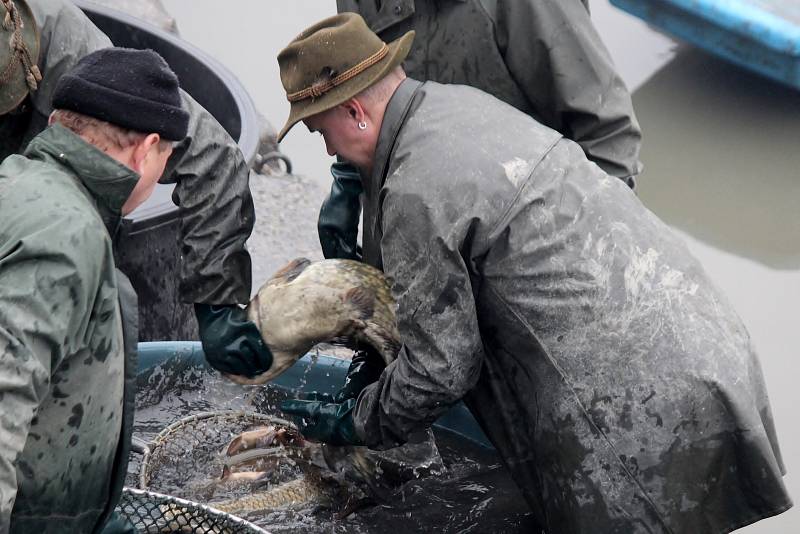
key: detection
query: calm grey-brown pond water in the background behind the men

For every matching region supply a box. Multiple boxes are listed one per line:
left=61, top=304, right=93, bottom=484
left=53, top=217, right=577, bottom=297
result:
left=152, top=0, right=800, bottom=534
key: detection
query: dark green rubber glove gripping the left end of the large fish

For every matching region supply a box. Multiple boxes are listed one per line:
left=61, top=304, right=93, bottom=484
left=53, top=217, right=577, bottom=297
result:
left=194, top=303, right=272, bottom=378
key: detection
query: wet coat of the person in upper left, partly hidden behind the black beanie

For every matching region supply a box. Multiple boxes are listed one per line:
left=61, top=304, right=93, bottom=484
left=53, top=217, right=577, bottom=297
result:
left=0, top=0, right=255, bottom=304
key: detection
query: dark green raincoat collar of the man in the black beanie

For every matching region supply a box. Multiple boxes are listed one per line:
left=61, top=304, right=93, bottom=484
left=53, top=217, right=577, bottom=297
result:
left=24, top=124, right=140, bottom=236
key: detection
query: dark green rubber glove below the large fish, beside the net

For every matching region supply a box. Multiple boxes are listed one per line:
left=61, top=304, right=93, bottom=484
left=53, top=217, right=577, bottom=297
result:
left=281, top=399, right=363, bottom=446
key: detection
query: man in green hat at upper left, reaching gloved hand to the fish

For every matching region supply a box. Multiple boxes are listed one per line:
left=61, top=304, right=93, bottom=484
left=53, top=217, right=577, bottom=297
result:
left=0, top=0, right=271, bottom=386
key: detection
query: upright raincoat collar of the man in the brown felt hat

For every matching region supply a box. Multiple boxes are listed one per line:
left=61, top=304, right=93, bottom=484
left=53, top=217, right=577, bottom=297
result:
left=364, top=78, right=422, bottom=196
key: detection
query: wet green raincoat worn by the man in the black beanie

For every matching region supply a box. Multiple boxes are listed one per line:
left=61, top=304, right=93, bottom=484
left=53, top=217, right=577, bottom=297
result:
left=0, top=126, right=138, bottom=534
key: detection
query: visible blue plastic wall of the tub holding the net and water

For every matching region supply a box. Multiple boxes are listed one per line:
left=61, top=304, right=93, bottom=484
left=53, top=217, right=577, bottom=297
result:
left=138, top=341, right=492, bottom=447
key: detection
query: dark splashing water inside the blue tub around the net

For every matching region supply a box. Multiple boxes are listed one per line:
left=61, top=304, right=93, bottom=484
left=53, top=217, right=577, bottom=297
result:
left=128, top=370, right=532, bottom=534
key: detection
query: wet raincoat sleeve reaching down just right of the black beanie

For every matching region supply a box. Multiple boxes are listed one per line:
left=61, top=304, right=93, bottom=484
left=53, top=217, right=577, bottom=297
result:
left=161, top=92, right=255, bottom=304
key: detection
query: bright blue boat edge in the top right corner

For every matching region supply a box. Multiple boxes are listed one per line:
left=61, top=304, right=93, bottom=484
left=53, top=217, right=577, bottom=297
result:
left=611, top=0, right=800, bottom=89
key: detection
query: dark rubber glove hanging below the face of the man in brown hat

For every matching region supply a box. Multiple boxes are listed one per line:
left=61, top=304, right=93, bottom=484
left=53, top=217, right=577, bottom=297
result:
left=317, top=161, right=362, bottom=260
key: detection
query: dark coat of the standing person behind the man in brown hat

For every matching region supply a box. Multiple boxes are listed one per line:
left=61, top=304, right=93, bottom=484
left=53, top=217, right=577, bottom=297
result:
left=337, top=0, right=641, bottom=178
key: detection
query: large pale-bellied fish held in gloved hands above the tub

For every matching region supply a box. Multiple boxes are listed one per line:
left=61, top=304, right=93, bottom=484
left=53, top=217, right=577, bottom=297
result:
left=227, top=258, right=400, bottom=384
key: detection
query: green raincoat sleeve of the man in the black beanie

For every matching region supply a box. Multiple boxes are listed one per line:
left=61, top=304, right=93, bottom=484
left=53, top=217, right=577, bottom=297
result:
left=0, top=220, right=107, bottom=534
